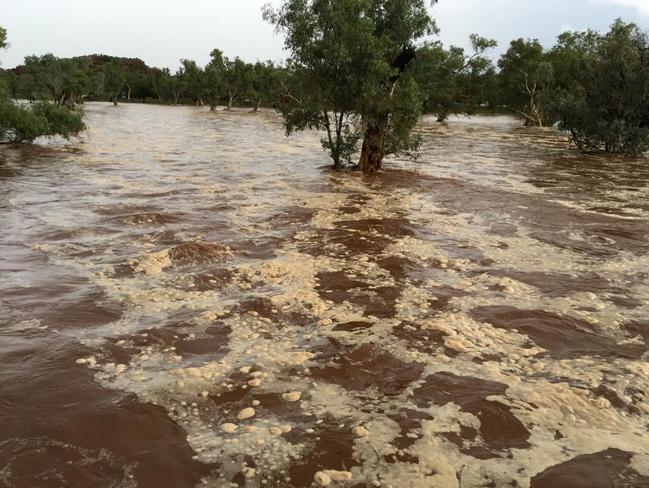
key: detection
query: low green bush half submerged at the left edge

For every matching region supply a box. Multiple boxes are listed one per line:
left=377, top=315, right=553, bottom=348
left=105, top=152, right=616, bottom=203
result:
left=0, top=27, right=85, bottom=143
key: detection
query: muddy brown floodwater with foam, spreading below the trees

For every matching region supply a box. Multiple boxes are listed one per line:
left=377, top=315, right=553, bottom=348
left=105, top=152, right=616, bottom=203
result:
left=0, top=104, right=649, bottom=488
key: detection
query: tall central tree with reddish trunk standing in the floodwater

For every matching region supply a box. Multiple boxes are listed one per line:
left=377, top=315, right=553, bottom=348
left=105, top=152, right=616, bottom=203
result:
left=264, top=0, right=435, bottom=172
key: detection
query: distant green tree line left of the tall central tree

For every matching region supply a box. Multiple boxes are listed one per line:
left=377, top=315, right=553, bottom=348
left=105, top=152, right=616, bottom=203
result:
left=5, top=49, right=286, bottom=110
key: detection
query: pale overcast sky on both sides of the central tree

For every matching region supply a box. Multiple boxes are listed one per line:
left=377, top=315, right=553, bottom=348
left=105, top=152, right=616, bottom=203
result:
left=0, top=0, right=649, bottom=68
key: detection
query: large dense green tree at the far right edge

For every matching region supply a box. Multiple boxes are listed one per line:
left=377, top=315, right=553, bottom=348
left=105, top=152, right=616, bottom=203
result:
left=551, top=20, right=649, bottom=154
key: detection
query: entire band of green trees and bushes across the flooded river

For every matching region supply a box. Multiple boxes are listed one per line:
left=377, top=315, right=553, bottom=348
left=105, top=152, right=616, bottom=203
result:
left=0, top=9, right=649, bottom=158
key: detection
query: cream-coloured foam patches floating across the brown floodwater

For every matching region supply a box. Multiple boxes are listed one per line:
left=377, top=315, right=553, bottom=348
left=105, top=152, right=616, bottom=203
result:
left=26, top=108, right=649, bottom=488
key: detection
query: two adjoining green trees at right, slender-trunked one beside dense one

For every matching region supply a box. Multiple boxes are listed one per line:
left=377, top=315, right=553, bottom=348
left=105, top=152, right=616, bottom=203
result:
left=492, top=20, right=649, bottom=153
